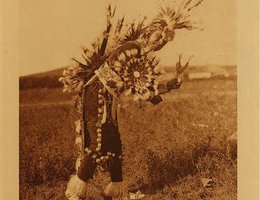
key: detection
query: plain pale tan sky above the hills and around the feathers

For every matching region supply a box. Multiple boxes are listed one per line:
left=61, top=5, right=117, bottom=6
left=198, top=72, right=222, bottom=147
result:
left=19, top=0, right=236, bottom=75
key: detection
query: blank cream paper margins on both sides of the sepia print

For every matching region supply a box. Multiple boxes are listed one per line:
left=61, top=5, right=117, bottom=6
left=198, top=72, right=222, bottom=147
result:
left=0, top=0, right=260, bottom=200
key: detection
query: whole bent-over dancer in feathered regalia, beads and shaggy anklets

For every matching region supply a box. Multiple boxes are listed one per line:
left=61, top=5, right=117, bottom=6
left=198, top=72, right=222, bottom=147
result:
left=60, top=0, right=202, bottom=200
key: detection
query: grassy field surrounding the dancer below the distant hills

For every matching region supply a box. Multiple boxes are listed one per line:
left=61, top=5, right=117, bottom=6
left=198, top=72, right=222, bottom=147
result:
left=20, top=79, right=237, bottom=200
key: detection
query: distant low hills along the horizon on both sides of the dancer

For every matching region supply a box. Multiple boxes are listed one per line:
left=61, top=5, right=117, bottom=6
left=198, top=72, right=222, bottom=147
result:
left=19, top=65, right=237, bottom=90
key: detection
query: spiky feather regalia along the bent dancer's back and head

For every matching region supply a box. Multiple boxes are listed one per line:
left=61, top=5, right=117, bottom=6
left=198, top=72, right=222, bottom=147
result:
left=60, top=0, right=203, bottom=91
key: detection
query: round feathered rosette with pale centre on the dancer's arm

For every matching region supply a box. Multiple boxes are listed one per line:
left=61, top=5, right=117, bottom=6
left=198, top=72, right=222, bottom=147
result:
left=106, top=49, right=160, bottom=101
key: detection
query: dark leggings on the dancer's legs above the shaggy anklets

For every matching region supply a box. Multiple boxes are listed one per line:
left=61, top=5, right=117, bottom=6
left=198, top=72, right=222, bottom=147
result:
left=77, top=84, right=122, bottom=182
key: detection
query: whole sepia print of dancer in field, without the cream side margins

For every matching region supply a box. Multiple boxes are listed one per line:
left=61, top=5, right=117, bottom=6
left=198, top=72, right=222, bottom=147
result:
left=0, top=0, right=259, bottom=200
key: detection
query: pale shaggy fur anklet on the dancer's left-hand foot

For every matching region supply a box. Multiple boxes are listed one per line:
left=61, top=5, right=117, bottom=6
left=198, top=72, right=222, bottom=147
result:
left=65, top=175, right=87, bottom=200
